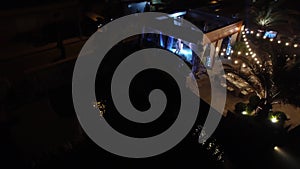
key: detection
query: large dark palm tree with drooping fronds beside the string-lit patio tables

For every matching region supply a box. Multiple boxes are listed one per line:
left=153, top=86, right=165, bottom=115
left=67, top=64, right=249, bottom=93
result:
left=225, top=30, right=300, bottom=119
